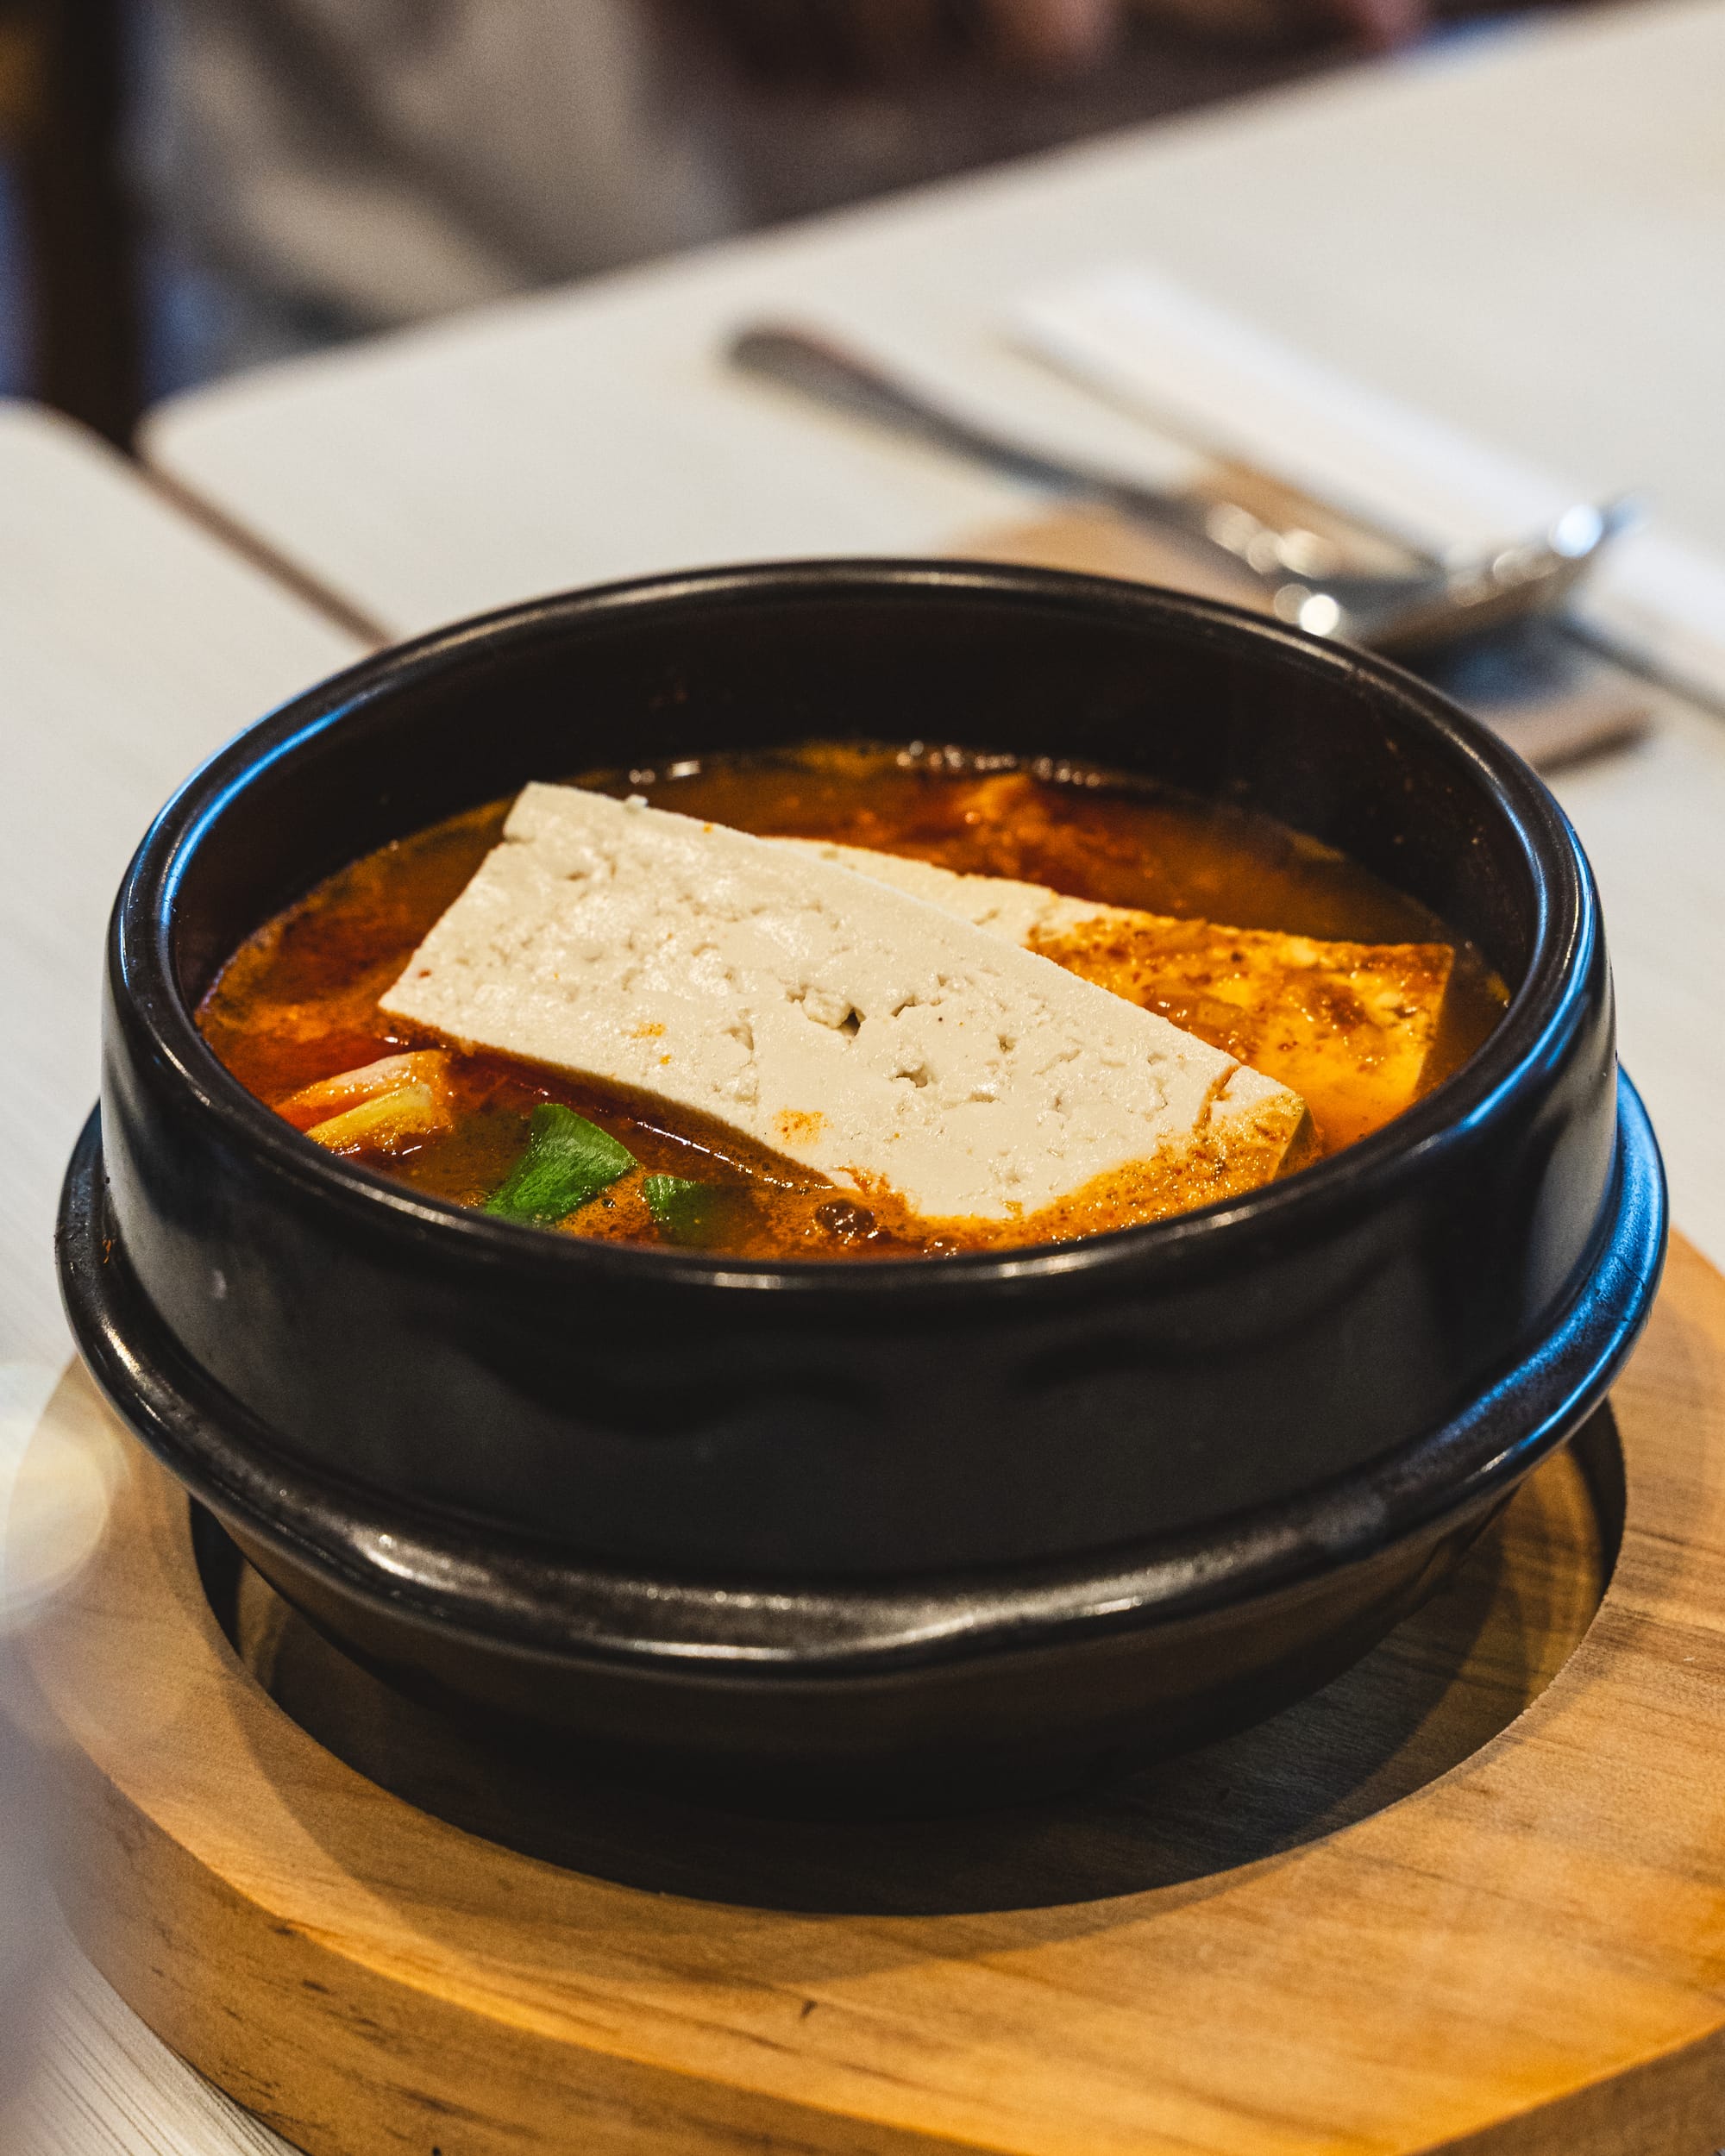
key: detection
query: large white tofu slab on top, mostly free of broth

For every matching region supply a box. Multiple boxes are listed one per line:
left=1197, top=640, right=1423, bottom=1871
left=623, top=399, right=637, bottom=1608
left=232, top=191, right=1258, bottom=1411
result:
left=382, top=785, right=1302, bottom=1220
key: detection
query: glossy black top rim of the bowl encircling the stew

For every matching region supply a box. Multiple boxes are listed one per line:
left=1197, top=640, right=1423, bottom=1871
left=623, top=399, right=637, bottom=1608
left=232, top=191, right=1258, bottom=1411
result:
left=108, top=561, right=1598, bottom=1307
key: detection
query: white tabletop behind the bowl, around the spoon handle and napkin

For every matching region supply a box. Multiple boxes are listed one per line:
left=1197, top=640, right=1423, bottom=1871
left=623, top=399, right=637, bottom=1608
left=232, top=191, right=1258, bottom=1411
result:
left=147, top=0, right=1725, bottom=634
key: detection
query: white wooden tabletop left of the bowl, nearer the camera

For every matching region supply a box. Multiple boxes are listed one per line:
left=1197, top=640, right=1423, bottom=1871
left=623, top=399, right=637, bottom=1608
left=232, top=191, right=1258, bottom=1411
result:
left=0, top=404, right=356, bottom=2156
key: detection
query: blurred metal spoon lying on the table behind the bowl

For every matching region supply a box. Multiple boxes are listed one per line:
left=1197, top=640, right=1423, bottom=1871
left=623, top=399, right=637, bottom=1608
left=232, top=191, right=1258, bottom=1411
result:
left=729, top=323, right=1637, bottom=654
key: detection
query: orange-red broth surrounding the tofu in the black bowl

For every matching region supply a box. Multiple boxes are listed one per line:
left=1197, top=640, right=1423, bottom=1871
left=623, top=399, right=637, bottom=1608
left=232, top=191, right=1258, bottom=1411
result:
left=198, top=744, right=1508, bottom=1259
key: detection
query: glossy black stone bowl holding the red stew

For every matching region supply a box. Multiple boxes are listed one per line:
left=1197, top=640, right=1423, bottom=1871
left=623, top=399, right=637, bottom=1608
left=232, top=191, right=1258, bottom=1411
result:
left=60, top=563, right=1665, bottom=1807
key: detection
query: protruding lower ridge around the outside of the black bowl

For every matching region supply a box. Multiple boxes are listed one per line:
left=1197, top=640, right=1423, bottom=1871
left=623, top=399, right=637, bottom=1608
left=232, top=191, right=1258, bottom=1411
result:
left=59, top=1072, right=1667, bottom=1684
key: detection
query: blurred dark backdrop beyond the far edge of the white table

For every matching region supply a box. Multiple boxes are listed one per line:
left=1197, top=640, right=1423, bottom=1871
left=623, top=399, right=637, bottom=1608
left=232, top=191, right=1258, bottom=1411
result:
left=0, top=0, right=1570, bottom=442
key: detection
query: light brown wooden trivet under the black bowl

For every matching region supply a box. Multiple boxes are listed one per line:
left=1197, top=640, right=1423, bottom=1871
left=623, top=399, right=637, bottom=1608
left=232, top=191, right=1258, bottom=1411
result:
left=13, top=1244, right=1725, bottom=2156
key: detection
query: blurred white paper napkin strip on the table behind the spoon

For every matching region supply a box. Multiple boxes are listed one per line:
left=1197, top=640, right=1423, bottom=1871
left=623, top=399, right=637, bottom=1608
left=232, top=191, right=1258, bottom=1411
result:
left=1009, top=266, right=1725, bottom=701
